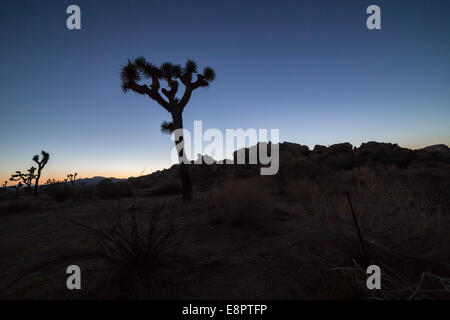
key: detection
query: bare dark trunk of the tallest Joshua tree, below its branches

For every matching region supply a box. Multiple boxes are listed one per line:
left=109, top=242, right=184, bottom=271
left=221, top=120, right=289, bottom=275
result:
left=172, top=110, right=192, bottom=201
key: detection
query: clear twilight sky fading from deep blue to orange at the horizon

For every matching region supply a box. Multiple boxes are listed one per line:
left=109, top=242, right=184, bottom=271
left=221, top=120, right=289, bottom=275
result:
left=0, top=0, right=450, bottom=181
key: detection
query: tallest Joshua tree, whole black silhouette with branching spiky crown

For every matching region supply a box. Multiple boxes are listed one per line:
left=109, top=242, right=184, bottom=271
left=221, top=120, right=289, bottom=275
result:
left=121, top=57, right=216, bottom=201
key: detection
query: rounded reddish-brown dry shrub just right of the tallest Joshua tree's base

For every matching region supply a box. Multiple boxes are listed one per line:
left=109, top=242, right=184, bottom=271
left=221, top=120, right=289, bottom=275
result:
left=204, top=178, right=270, bottom=226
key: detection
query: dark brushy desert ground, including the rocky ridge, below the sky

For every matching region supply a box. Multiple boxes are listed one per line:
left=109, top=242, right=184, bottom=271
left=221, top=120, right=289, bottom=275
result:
left=0, top=142, right=450, bottom=299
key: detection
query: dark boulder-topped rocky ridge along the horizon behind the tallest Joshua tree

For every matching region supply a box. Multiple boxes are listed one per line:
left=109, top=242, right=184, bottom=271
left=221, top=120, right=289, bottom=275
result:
left=130, top=141, right=450, bottom=187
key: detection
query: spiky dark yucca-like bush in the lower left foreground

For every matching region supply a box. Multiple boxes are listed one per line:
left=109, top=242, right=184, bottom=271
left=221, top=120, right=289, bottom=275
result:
left=69, top=203, right=176, bottom=298
